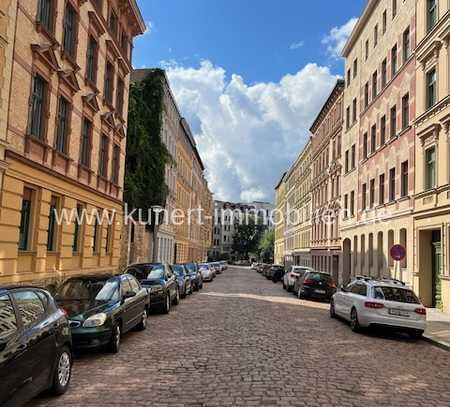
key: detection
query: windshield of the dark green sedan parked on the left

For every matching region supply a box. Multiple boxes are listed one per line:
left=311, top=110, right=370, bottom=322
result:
left=55, top=280, right=119, bottom=302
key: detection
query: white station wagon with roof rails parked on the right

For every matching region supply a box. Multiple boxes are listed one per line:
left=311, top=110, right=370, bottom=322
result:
left=330, top=277, right=427, bottom=338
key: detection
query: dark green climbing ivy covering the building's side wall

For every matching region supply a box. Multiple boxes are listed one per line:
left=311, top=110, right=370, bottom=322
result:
left=124, top=69, right=172, bottom=229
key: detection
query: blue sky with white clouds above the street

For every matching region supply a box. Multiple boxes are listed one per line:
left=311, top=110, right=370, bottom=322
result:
left=133, top=0, right=367, bottom=202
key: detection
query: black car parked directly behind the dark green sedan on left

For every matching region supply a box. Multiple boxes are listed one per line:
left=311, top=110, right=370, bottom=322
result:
left=126, top=263, right=180, bottom=314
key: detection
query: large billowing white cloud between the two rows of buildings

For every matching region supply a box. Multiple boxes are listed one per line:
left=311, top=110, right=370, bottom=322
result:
left=167, top=61, right=337, bottom=201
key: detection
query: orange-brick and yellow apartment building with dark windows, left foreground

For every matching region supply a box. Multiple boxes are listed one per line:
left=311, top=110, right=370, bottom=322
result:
left=0, top=0, right=145, bottom=284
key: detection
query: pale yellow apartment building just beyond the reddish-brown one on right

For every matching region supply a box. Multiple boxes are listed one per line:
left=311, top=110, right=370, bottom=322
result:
left=284, top=141, right=312, bottom=267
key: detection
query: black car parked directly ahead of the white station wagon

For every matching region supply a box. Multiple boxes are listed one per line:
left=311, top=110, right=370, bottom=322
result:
left=297, top=271, right=336, bottom=301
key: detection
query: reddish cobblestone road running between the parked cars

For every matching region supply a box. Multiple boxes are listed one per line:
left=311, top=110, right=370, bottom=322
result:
left=33, top=268, right=450, bottom=407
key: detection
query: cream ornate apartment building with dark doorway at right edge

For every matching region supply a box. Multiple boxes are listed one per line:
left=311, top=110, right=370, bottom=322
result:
left=409, top=0, right=450, bottom=312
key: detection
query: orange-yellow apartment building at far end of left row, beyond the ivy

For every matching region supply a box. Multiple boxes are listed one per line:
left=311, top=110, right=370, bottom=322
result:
left=175, top=119, right=212, bottom=263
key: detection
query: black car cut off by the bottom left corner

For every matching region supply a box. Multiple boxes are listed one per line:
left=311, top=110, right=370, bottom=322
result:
left=0, top=287, right=72, bottom=407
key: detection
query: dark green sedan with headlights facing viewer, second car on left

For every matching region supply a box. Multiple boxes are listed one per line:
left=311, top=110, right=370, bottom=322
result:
left=55, top=274, right=149, bottom=353
